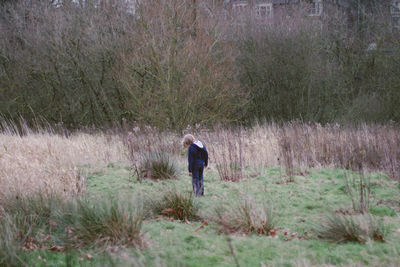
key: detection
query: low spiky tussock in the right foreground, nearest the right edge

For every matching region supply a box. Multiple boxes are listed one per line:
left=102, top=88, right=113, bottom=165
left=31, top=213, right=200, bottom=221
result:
left=315, top=213, right=386, bottom=243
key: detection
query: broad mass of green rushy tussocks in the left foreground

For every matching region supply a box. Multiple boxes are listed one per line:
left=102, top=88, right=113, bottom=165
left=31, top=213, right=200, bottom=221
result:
left=0, top=195, right=142, bottom=266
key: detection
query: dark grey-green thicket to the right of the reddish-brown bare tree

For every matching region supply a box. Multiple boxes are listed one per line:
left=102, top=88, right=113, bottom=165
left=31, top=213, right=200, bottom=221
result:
left=236, top=12, right=400, bottom=122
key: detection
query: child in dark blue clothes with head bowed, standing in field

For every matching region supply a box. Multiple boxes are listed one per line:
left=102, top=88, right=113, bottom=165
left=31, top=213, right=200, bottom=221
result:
left=182, top=134, right=208, bottom=196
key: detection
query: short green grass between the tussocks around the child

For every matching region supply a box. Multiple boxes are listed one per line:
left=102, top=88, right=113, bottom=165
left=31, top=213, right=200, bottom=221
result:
left=5, top=162, right=400, bottom=266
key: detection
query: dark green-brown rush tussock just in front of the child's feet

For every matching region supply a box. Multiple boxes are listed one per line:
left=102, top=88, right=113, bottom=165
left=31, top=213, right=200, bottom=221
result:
left=150, top=189, right=200, bottom=221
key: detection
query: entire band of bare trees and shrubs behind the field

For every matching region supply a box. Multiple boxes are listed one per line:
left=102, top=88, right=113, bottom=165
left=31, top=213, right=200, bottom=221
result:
left=0, top=0, right=400, bottom=129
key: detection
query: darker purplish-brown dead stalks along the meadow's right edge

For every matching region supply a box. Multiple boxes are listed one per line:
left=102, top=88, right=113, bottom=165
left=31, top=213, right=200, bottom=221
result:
left=266, top=122, right=400, bottom=178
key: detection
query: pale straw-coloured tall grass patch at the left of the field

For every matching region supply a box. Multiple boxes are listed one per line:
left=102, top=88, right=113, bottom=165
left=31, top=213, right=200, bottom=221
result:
left=0, top=126, right=126, bottom=199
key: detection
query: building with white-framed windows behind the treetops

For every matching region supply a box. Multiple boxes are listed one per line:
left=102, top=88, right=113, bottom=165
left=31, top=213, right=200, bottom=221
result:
left=225, top=0, right=400, bottom=34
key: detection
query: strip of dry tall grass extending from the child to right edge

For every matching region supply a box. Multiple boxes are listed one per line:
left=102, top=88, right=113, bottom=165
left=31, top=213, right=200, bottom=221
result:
left=200, top=122, right=400, bottom=180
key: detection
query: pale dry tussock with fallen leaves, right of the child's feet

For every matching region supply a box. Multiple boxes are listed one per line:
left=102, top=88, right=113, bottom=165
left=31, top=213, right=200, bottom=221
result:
left=216, top=199, right=275, bottom=235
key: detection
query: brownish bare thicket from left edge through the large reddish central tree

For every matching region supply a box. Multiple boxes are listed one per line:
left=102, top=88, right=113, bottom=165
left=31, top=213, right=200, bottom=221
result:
left=0, top=0, right=240, bottom=129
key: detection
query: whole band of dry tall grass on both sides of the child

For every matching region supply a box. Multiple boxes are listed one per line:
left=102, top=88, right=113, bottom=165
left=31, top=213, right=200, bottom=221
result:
left=0, top=123, right=400, bottom=199
